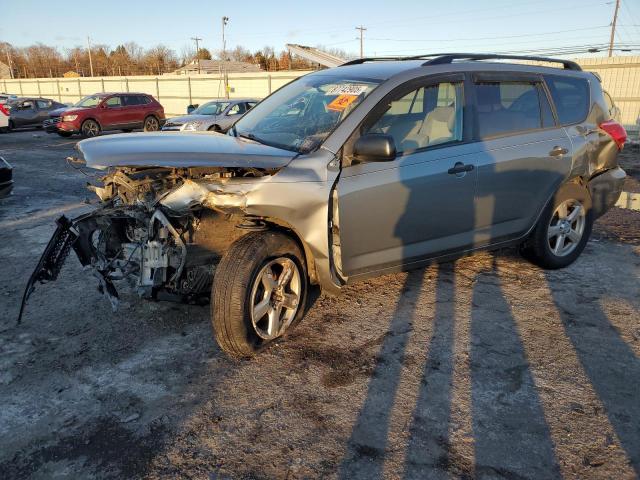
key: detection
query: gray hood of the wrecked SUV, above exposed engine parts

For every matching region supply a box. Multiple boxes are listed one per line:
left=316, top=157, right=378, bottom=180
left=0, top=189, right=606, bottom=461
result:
left=76, top=132, right=296, bottom=169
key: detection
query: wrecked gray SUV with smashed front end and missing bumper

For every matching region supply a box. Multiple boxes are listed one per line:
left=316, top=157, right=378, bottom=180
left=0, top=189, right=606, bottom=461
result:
left=27, top=54, right=626, bottom=357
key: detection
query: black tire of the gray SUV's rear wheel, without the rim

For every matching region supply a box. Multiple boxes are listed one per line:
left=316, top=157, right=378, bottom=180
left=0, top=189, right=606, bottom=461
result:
left=521, top=183, right=593, bottom=270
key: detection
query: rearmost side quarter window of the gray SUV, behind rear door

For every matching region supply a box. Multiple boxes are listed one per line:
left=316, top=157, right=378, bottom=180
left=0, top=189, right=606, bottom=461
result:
left=545, top=75, right=590, bottom=125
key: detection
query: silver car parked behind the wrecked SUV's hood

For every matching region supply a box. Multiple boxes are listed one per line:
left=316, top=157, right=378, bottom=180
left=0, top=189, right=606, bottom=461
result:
left=162, top=98, right=258, bottom=132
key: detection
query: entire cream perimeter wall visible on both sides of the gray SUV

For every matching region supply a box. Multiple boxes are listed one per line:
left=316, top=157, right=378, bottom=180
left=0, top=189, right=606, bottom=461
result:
left=0, top=56, right=640, bottom=134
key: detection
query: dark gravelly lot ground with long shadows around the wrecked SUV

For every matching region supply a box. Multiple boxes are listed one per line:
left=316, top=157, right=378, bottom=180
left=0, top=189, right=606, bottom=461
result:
left=0, top=131, right=640, bottom=479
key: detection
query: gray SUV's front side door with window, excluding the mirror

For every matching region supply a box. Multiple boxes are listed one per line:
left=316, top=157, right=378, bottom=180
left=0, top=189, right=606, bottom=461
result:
left=337, top=76, right=477, bottom=277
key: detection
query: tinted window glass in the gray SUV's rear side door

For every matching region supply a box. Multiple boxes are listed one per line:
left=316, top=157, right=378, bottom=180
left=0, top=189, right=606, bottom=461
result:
left=475, top=81, right=553, bottom=138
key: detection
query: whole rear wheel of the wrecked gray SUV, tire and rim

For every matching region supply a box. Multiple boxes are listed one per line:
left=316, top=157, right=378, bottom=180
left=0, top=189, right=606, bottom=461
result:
left=523, top=184, right=593, bottom=269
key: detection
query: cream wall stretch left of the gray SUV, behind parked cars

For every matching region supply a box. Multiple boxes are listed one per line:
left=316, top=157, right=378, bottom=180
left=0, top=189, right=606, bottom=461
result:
left=0, top=71, right=309, bottom=116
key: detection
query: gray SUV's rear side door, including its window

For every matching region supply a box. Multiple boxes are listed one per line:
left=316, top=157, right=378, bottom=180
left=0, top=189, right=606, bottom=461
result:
left=472, top=72, right=572, bottom=246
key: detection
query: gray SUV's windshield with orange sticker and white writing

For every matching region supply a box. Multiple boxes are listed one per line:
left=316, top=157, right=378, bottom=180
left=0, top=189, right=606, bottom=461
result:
left=232, top=75, right=379, bottom=153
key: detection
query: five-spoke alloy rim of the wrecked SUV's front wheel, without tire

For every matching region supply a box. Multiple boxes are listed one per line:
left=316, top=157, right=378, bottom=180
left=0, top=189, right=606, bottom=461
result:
left=249, top=257, right=302, bottom=340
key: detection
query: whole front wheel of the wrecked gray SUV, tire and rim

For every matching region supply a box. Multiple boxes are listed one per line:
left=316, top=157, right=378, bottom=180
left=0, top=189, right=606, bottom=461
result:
left=211, top=231, right=308, bottom=357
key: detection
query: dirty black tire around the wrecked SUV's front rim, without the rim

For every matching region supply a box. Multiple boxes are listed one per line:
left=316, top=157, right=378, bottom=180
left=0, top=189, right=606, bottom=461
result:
left=211, top=231, right=309, bottom=358
